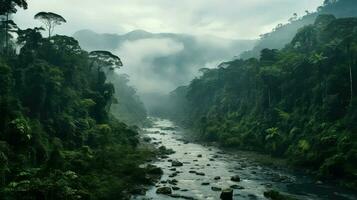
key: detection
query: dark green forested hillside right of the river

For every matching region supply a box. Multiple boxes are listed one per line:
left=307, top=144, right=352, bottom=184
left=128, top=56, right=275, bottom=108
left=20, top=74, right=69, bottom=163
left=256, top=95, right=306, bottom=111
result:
left=168, top=15, right=357, bottom=188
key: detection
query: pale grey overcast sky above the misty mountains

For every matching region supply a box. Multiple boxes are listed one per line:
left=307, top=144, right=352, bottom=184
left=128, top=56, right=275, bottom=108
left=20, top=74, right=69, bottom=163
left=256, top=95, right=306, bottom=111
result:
left=15, top=0, right=323, bottom=39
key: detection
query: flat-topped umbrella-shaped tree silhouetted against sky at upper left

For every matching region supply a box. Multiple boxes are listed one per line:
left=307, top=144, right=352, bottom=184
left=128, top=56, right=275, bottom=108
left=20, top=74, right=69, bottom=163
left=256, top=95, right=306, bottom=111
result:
left=35, top=12, right=67, bottom=38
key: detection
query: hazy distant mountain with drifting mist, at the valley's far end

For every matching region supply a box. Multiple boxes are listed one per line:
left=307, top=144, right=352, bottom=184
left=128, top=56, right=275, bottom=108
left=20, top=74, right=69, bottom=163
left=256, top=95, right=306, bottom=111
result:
left=73, top=30, right=255, bottom=93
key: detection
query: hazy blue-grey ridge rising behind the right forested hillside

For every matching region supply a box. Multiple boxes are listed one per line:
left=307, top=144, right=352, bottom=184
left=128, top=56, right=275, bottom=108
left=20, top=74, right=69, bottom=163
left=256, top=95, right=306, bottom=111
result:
left=240, top=0, right=357, bottom=59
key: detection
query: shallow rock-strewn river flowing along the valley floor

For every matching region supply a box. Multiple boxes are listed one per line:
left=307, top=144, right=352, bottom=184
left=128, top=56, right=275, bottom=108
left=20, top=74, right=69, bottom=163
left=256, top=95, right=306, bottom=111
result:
left=133, top=119, right=357, bottom=200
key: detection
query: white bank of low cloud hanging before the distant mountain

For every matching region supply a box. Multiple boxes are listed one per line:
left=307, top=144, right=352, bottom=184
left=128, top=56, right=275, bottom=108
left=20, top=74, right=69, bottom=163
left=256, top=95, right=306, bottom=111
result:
left=116, top=38, right=184, bottom=93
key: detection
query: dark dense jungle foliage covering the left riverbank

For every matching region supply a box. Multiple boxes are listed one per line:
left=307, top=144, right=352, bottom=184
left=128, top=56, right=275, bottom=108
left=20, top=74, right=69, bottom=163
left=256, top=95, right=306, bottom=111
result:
left=0, top=0, right=151, bottom=200
